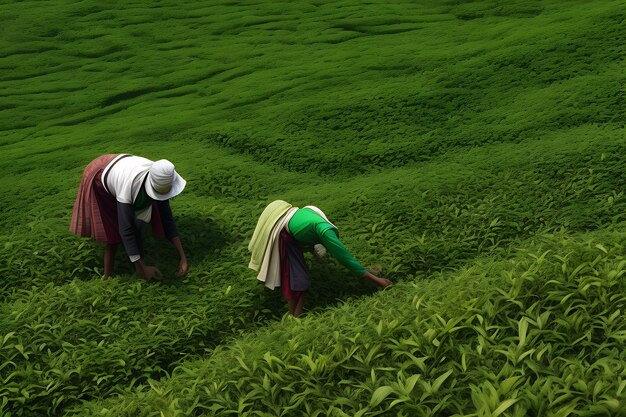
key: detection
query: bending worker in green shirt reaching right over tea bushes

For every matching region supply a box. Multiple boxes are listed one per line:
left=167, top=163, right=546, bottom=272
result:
left=248, top=200, right=391, bottom=316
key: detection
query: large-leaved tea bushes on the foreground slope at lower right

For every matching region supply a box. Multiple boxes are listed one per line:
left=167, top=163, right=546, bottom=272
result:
left=77, top=231, right=626, bottom=417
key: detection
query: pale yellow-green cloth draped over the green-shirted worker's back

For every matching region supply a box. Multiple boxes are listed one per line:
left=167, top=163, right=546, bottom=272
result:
left=248, top=200, right=298, bottom=290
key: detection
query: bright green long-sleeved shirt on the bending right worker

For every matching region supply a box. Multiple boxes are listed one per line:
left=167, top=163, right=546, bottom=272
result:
left=289, top=208, right=365, bottom=276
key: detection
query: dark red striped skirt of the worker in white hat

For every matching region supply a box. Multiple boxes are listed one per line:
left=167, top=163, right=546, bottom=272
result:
left=70, top=154, right=164, bottom=243
